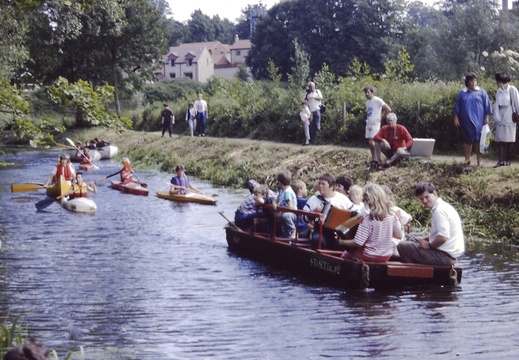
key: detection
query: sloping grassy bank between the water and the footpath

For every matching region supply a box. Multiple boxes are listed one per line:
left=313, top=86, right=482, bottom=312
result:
left=65, top=128, right=519, bottom=245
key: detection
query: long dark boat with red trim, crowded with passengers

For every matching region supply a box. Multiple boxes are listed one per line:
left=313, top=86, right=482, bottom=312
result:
left=225, top=208, right=462, bottom=288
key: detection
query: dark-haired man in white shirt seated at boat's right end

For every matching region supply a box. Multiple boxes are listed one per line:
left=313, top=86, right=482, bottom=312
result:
left=397, top=182, right=465, bottom=266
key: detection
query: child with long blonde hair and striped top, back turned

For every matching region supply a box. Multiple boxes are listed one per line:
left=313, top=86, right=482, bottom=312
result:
left=341, top=183, right=402, bottom=262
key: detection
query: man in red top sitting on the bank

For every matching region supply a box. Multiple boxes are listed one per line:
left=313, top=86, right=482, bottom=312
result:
left=373, top=113, right=413, bottom=170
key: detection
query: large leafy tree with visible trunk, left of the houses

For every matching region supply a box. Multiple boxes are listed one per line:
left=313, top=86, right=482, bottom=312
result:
left=25, top=0, right=167, bottom=115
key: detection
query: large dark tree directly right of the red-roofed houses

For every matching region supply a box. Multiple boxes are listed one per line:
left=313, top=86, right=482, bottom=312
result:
left=247, top=0, right=405, bottom=78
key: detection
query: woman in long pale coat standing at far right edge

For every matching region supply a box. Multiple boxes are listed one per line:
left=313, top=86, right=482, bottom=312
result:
left=494, top=73, right=519, bottom=168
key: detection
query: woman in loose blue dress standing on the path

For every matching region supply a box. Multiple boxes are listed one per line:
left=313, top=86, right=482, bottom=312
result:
left=454, top=73, right=492, bottom=166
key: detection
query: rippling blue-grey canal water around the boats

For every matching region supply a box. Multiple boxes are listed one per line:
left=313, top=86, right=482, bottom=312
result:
left=0, top=149, right=519, bottom=360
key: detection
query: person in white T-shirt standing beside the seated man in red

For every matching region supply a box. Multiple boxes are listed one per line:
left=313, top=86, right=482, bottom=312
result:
left=364, top=85, right=391, bottom=170
